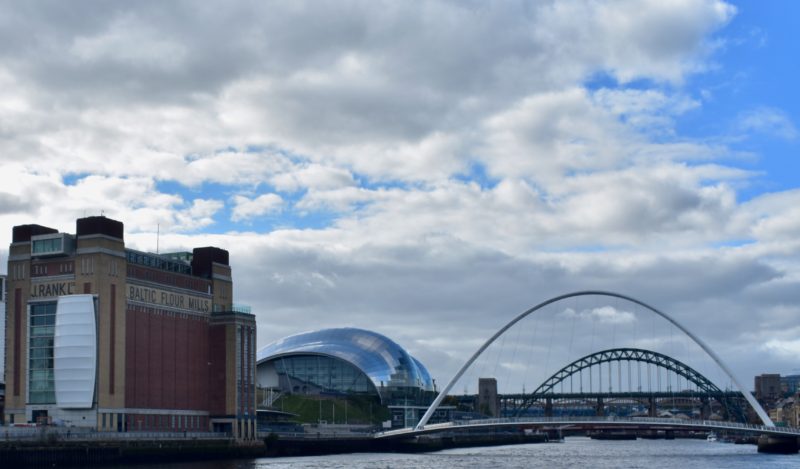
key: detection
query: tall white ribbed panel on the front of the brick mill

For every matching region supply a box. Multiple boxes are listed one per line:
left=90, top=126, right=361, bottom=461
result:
left=53, top=295, right=97, bottom=409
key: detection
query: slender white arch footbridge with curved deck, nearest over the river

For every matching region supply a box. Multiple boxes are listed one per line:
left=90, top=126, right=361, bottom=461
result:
left=382, top=290, right=800, bottom=438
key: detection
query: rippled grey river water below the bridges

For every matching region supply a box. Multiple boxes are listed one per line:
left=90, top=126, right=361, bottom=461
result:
left=109, top=437, right=800, bottom=469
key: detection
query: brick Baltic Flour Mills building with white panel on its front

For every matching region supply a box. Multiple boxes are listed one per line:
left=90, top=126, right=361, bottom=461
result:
left=5, top=217, right=256, bottom=438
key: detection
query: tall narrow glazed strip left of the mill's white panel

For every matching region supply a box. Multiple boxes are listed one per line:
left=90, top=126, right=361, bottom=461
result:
left=28, top=302, right=56, bottom=404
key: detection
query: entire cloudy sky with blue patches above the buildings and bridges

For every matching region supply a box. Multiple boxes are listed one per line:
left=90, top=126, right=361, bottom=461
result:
left=0, top=0, right=800, bottom=394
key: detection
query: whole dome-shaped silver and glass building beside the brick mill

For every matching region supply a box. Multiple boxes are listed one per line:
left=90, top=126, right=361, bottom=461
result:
left=256, top=328, right=435, bottom=425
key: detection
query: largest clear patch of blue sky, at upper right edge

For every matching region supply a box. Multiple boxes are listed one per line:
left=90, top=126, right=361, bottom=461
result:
left=678, top=1, right=800, bottom=199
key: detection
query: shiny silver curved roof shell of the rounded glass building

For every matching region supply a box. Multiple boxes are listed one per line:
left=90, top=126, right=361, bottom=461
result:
left=256, top=327, right=433, bottom=392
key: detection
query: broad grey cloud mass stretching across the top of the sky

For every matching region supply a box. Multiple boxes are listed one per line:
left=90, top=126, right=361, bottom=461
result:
left=0, top=1, right=733, bottom=183
